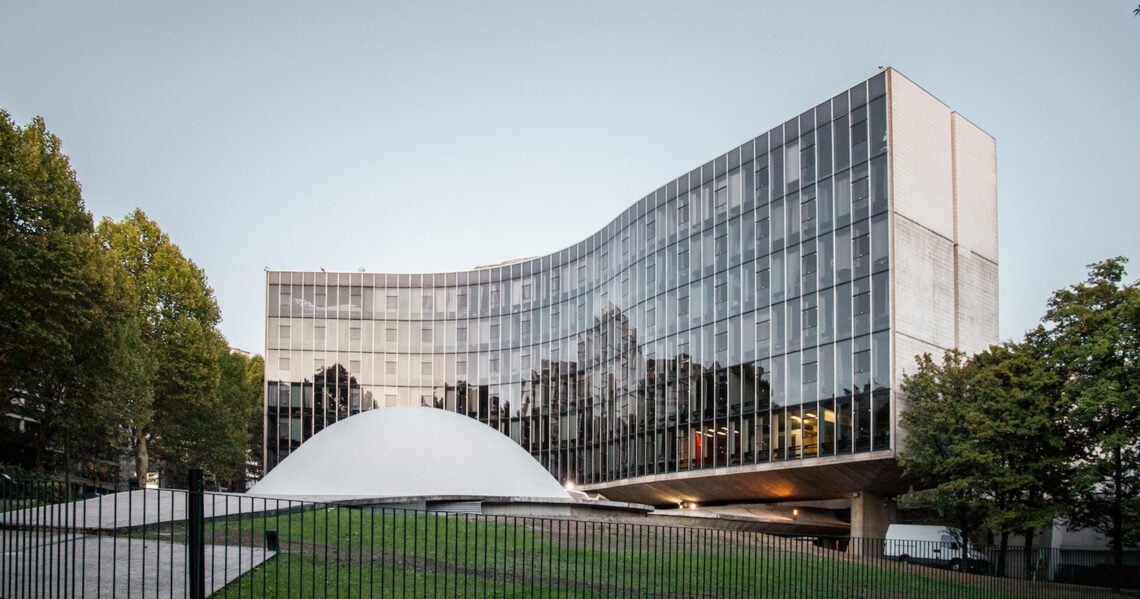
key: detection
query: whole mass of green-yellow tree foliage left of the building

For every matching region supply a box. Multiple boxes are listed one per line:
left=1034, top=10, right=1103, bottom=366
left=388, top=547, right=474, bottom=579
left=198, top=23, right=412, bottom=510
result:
left=0, top=111, right=262, bottom=490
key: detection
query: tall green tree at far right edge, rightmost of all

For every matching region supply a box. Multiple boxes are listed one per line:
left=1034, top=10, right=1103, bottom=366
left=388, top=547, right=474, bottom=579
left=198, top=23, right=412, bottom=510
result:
left=1035, top=258, right=1140, bottom=589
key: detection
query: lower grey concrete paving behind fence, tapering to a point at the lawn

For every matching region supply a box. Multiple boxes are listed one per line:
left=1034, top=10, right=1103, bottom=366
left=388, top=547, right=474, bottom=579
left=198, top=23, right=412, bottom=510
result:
left=0, top=531, right=274, bottom=599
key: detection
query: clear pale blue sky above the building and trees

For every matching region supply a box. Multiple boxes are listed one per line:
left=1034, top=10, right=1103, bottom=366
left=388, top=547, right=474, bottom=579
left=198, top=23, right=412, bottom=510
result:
left=0, top=0, right=1140, bottom=353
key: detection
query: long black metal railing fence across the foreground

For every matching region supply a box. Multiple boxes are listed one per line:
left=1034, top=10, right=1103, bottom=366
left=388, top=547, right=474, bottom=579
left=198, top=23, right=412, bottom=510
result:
left=0, top=483, right=1137, bottom=598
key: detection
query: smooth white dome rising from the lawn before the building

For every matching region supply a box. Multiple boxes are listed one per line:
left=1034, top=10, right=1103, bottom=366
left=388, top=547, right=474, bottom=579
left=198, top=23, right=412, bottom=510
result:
left=249, top=406, right=569, bottom=500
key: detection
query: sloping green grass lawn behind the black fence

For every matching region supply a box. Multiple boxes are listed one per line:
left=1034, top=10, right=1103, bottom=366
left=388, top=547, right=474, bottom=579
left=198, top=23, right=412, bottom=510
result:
left=206, top=508, right=1028, bottom=598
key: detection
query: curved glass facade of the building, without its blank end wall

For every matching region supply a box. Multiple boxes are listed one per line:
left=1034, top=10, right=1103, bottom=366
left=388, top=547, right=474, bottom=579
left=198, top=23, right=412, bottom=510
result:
left=266, top=73, right=925, bottom=499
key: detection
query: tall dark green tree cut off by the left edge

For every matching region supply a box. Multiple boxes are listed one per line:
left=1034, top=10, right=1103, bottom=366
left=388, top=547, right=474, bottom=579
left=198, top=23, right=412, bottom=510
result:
left=0, top=111, right=141, bottom=476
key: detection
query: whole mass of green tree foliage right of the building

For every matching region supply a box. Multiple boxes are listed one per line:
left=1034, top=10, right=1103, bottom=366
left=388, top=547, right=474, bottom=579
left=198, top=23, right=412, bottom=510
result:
left=899, top=258, right=1140, bottom=584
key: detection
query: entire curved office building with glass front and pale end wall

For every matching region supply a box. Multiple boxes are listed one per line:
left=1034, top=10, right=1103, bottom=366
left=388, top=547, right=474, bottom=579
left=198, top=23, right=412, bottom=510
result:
left=264, top=70, right=998, bottom=531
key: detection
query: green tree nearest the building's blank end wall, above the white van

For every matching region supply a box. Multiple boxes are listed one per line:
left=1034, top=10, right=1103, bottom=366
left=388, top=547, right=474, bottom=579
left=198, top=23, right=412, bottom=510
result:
left=898, top=350, right=991, bottom=567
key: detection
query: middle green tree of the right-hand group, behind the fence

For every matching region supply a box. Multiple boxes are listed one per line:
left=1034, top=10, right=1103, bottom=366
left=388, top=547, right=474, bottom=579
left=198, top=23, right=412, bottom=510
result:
left=968, top=341, right=1068, bottom=576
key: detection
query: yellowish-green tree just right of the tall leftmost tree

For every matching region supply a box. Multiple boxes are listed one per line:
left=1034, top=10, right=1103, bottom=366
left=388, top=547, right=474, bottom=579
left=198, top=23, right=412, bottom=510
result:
left=96, top=210, right=223, bottom=480
